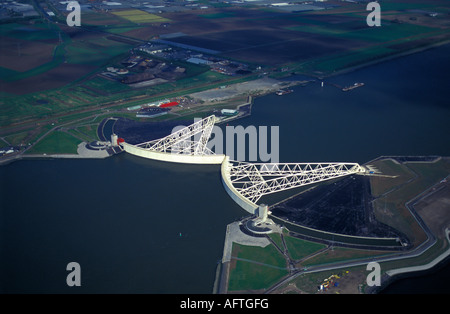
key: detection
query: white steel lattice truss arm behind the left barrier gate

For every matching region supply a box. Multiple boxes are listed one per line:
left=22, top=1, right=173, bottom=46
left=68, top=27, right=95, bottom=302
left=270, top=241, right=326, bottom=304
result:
left=136, top=115, right=216, bottom=155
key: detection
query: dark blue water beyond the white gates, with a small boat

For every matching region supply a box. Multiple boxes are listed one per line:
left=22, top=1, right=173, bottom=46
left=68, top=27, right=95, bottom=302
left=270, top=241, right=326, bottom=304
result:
left=225, top=45, right=450, bottom=163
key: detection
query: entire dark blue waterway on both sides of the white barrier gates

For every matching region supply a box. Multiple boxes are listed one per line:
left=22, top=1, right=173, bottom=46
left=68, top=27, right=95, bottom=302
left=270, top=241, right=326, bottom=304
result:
left=0, top=46, right=450, bottom=293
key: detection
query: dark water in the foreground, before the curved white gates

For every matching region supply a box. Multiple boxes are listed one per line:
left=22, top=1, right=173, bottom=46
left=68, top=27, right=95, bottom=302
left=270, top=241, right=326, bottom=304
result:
left=0, top=154, right=244, bottom=293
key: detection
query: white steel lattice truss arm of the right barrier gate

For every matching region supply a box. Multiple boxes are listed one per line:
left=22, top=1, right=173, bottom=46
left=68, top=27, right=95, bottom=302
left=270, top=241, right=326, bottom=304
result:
left=228, top=161, right=364, bottom=204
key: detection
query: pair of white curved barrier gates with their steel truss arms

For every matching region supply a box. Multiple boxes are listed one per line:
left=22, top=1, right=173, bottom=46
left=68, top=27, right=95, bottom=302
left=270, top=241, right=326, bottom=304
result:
left=120, top=115, right=366, bottom=217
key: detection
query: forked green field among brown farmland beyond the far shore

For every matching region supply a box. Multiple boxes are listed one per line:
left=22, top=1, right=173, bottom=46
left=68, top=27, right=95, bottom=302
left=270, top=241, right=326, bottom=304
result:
left=287, top=16, right=448, bottom=75
